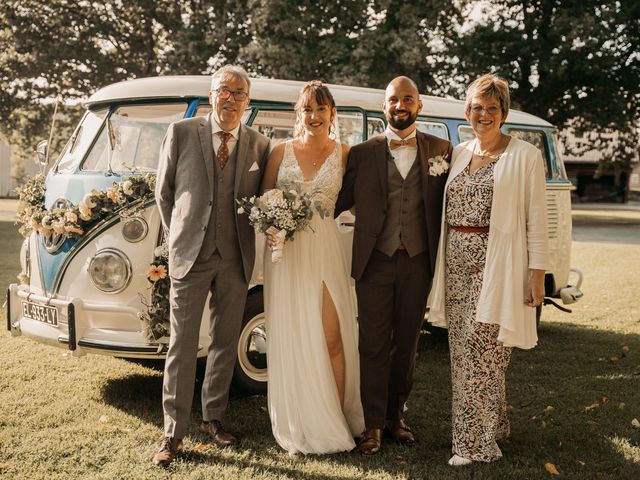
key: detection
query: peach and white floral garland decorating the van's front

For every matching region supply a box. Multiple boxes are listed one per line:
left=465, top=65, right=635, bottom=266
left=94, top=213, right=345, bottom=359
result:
left=16, top=173, right=170, bottom=343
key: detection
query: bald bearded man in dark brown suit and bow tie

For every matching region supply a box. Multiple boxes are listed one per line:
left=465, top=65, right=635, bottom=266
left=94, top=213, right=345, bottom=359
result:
left=335, top=77, right=452, bottom=455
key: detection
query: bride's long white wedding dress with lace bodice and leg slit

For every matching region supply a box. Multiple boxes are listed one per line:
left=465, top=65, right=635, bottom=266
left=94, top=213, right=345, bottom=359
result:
left=264, top=142, right=364, bottom=454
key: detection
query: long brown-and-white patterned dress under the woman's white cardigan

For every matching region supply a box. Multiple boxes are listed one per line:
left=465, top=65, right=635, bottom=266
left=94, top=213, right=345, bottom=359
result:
left=445, top=162, right=511, bottom=462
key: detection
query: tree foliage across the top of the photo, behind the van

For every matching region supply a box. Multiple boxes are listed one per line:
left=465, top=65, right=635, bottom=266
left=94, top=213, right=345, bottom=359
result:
left=0, top=0, right=640, bottom=180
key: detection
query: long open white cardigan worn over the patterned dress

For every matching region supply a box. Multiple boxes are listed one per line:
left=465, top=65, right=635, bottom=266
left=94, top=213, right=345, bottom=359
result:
left=428, top=137, right=549, bottom=349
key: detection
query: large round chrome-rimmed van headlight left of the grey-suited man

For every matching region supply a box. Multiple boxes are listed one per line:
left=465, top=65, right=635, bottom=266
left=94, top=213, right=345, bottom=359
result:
left=89, top=248, right=131, bottom=293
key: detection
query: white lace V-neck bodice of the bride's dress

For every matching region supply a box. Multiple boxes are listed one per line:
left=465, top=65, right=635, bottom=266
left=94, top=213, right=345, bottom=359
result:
left=276, top=141, right=343, bottom=215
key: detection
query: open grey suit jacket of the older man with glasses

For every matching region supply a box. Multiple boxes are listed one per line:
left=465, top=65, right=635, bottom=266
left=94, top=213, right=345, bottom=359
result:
left=155, top=114, right=269, bottom=282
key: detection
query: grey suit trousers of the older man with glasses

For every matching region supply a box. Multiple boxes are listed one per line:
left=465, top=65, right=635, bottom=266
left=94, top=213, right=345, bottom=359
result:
left=162, top=252, right=247, bottom=438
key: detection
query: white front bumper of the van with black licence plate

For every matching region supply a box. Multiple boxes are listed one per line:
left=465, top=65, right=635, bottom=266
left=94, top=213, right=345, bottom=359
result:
left=7, top=284, right=166, bottom=358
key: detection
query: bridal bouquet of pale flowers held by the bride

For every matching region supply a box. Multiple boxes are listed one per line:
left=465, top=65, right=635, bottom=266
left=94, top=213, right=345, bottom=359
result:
left=236, top=187, right=326, bottom=263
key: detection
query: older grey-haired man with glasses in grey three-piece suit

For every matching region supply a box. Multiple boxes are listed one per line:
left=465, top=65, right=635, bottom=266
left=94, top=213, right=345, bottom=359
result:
left=153, top=66, right=269, bottom=467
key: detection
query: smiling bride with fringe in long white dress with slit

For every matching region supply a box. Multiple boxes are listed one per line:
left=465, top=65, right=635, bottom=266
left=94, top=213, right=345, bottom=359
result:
left=262, top=81, right=364, bottom=454
